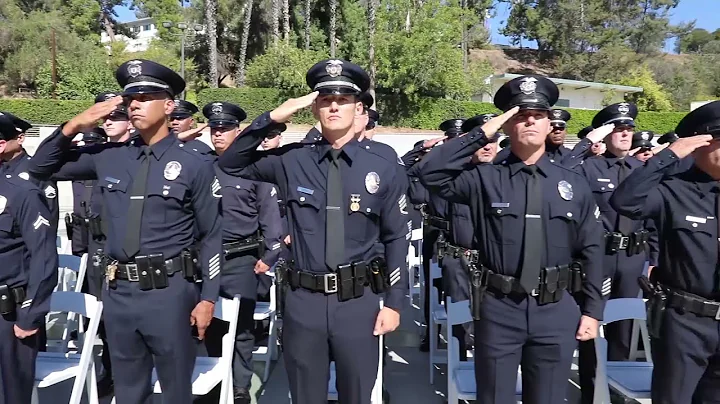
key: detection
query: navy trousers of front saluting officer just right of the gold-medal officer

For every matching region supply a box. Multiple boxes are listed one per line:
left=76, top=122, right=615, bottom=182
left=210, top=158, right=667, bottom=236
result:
left=475, top=289, right=580, bottom=404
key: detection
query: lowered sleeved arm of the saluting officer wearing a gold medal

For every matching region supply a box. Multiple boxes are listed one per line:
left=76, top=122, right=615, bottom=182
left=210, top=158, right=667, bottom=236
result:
left=380, top=169, right=412, bottom=312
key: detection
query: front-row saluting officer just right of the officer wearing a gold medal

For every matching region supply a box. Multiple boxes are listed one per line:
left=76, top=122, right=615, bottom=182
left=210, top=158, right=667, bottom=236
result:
left=420, top=75, right=604, bottom=404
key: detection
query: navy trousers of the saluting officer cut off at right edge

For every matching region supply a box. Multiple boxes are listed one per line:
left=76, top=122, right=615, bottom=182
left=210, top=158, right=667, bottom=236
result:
left=651, top=309, right=720, bottom=404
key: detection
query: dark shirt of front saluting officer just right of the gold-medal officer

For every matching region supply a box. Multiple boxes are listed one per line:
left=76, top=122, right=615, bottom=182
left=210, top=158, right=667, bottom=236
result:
left=419, top=128, right=604, bottom=320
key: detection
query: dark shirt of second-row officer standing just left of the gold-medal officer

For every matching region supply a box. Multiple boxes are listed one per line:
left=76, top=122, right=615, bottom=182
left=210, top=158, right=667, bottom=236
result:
left=215, top=167, right=285, bottom=266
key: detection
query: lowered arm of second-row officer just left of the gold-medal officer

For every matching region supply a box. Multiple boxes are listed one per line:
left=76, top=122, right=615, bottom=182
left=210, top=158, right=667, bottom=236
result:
left=255, top=182, right=285, bottom=266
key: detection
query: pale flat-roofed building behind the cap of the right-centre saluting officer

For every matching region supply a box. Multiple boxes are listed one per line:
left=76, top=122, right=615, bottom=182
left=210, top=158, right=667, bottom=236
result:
left=474, top=73, right=643, bottom=110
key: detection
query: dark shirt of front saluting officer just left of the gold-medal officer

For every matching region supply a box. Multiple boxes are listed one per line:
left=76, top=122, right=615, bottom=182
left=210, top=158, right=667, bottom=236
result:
left=29, top=127, right=222, bottom=302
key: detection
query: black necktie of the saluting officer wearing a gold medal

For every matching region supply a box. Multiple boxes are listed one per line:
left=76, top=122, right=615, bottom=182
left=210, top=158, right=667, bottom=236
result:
left=325, top=149, right=346, bottom=272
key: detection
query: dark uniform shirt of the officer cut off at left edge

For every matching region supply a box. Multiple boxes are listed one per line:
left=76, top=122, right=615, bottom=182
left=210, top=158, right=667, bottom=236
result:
left=0, top=176, right=58, bottom=330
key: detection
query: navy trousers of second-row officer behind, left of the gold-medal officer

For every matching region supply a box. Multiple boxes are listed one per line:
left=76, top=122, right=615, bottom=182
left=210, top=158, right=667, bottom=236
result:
left=205, top=254, right=258, bottom=389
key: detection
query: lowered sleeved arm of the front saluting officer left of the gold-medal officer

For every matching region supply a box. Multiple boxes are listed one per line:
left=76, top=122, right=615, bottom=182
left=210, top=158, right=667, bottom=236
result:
left=191, top=160, right=223, bottom=303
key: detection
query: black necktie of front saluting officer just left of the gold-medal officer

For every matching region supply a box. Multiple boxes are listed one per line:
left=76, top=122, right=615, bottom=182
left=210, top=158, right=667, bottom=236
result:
left=123, top=146, right=150, bottom=259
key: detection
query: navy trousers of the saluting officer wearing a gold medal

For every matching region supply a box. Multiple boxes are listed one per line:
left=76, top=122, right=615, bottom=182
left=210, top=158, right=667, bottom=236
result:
left=282, top=287, right=380, bottom=404
